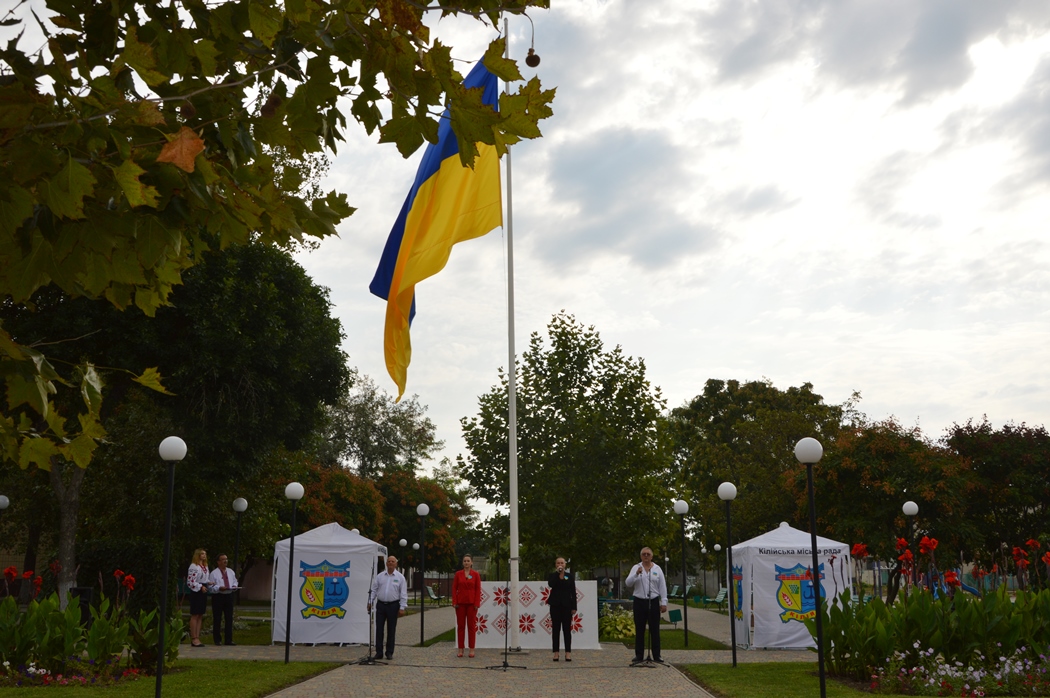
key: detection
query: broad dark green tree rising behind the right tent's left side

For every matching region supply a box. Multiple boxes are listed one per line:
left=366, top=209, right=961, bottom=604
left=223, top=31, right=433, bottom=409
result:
left=670, top=379, right=856, bottom=548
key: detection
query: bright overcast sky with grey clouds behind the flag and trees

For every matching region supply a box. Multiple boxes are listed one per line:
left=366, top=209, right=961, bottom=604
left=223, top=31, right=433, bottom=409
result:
left=300, top=0, right=1050, bottom=478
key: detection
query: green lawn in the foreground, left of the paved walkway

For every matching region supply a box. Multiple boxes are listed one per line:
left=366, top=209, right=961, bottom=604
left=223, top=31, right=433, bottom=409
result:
left=0, top=659, right=341, bottom=698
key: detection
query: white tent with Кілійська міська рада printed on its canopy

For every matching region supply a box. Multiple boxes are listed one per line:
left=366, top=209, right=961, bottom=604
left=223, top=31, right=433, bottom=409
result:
left=733, top=523, right=853, bottom=649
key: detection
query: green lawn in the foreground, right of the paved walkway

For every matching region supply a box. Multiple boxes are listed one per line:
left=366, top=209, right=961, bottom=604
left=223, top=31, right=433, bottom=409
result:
left=683, top=661, right=903, bottom=698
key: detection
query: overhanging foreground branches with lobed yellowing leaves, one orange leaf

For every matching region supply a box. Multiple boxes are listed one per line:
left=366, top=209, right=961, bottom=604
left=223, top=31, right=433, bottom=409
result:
left=0, top=0, right=553, bottom=484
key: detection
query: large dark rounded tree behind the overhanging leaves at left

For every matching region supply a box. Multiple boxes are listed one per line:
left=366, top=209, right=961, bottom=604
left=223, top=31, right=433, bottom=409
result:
left=2, top=244, right=349, bottom=591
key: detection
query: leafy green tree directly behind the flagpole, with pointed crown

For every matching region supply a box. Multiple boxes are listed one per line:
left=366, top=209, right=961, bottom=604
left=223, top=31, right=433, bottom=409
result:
left=460, top=313, right=673, bottom=573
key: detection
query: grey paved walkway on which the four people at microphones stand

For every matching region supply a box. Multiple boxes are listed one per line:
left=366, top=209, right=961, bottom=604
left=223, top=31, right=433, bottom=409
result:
left=193, top=606, right=814, bottom=698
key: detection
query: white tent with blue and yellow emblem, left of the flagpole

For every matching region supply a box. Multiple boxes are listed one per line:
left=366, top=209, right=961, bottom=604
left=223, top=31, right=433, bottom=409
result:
left=271, top=524, right=386, bottom=644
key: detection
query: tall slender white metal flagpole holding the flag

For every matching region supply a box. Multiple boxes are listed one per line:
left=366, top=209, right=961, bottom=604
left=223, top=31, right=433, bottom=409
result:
left=503, top=17, right=521, bottom=652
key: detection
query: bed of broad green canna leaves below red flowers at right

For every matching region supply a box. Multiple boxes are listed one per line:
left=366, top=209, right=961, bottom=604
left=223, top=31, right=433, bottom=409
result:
left=805, top=590, right=1050, bottom=680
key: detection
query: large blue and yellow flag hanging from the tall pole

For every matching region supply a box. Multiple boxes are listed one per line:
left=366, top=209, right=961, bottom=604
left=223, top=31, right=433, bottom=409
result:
left=369, top=61, right=503, bottom=399
